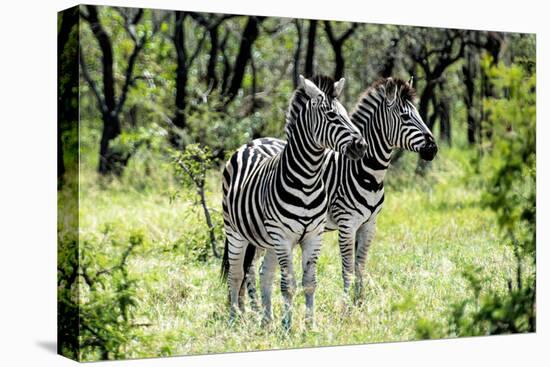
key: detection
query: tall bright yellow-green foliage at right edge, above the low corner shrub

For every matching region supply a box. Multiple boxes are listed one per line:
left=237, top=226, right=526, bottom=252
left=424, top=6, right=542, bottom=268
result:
left=484, top=59, right=536, bottom=256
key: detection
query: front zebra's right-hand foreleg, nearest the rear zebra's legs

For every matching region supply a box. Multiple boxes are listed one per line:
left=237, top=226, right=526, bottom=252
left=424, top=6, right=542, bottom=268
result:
left=302, top=236, right=321, bottom=326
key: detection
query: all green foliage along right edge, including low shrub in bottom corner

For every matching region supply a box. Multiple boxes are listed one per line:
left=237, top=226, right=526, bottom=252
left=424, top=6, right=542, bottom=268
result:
left=416, top=59, right=536, bottom=338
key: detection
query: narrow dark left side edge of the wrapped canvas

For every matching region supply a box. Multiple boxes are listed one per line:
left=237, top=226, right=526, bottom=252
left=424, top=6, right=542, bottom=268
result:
left=57, top=7, right=80, bottom=359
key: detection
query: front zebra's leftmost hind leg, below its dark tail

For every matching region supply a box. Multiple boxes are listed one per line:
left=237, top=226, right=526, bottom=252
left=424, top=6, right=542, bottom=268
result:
left=226, top=231, right=248, bottom=323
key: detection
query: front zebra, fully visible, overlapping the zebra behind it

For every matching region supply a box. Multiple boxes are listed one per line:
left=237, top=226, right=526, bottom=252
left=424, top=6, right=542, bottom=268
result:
left=221, top=76, right=366, bottom=329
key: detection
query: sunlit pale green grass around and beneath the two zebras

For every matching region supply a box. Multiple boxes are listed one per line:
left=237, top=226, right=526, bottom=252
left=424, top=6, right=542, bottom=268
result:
left=80, top=149, right=528, bottom=358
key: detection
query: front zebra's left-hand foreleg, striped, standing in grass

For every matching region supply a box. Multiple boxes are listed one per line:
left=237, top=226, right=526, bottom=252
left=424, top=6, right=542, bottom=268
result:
left=275, top=243, right=296, bottom=330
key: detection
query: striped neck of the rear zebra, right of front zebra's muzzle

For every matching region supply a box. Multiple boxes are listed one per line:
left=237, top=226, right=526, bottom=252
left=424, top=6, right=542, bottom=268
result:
left=350, top=91, right=393, bottom=183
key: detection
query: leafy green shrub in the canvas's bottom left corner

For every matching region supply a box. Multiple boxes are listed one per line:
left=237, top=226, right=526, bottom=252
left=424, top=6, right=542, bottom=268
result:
left=58, top=225, right=144, bottom=361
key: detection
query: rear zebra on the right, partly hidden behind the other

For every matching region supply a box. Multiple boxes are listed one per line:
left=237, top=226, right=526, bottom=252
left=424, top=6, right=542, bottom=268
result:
left=246, top=77, right=437, bottom=312
